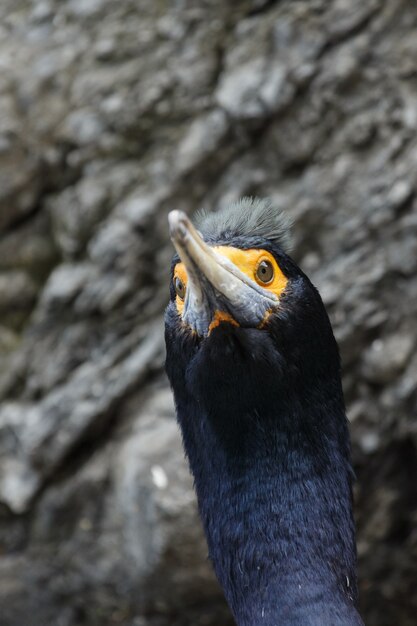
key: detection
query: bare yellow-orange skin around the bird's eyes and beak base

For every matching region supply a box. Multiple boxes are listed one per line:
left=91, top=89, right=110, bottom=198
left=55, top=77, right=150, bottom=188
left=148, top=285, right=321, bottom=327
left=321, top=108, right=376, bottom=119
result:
left=174, top=246, right=288, bottom=331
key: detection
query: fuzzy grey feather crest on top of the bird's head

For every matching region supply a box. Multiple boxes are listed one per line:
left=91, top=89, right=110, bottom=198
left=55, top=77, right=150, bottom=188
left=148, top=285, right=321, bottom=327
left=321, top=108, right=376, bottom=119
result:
left=196, top=197, right=292, bottom=252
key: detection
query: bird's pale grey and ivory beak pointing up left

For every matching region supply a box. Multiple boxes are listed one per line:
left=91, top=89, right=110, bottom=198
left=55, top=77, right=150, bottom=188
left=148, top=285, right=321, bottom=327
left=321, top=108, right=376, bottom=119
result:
left=169, top=211, right=279, bottom=336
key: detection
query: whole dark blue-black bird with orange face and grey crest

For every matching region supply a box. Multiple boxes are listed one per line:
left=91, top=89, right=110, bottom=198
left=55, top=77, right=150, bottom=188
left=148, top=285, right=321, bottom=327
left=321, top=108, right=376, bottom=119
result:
left=165, top=199, right=363, bottom=626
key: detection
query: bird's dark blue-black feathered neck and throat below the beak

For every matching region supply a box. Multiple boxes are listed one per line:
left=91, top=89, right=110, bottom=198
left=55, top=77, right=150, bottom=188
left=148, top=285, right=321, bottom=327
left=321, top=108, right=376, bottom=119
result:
left=167, top=316, right=362, bottom=626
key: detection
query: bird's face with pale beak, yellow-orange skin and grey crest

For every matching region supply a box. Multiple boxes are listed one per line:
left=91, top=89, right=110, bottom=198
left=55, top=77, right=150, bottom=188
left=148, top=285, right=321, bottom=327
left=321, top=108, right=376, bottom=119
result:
left=169, top=198, right=316, bottom=339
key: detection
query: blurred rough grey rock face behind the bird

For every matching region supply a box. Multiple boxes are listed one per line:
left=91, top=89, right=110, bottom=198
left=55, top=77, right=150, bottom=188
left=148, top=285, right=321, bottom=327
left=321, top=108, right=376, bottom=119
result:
left=0, top=0, right=417, bottom=626
